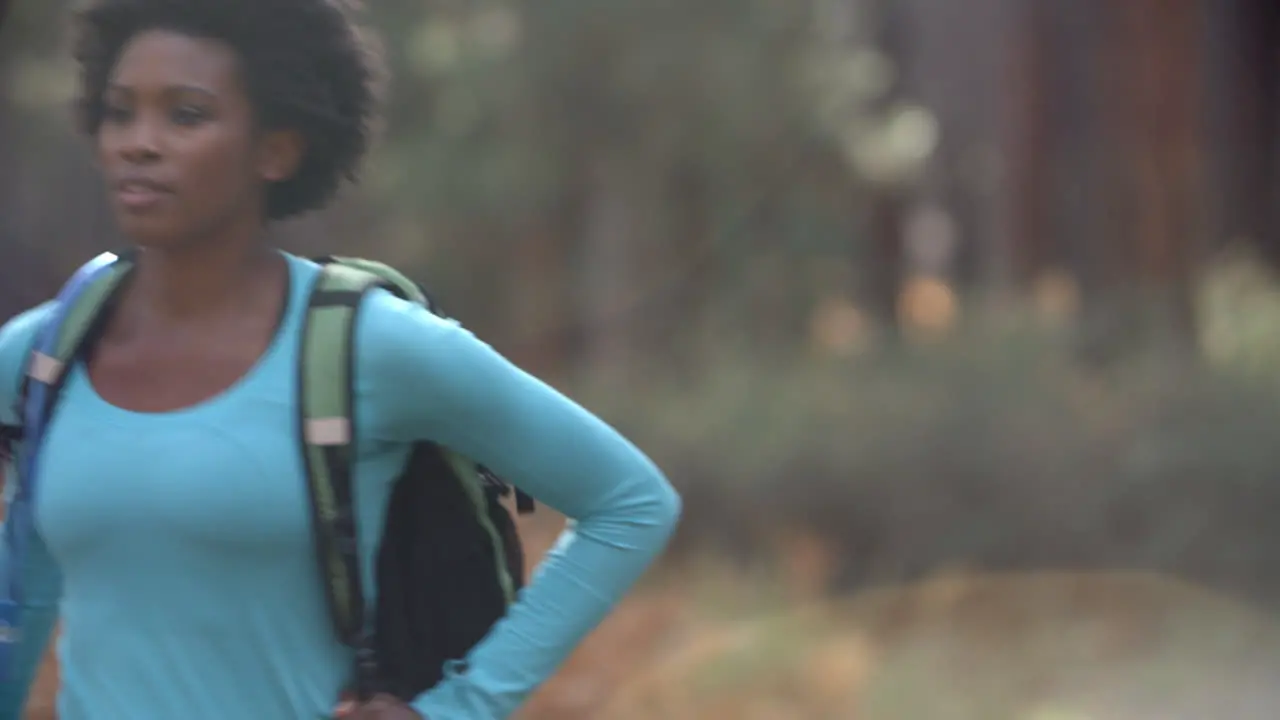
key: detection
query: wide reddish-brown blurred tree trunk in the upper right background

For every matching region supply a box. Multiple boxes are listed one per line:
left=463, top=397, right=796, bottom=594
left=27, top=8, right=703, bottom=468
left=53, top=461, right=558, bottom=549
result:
left=1009, top=0, right=1208, bottom=363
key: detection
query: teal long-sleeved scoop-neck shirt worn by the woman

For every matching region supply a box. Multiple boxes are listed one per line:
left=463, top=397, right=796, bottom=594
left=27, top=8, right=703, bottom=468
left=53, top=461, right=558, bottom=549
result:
left=0, top=256, right=680, bottom=720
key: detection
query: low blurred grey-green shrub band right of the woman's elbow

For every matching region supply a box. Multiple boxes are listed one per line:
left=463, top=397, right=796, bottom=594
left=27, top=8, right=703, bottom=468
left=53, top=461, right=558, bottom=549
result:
left=589, top=295, right=1280, bottom=584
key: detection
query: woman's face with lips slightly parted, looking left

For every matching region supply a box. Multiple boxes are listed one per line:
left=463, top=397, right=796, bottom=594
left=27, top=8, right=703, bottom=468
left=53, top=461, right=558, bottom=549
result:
left=97, top=31, right=288, bottom=247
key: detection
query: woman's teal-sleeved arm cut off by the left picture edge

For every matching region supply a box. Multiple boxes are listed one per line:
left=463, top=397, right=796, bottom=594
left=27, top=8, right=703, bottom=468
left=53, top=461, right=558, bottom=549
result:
left=0, top=304, right=61, bottom=720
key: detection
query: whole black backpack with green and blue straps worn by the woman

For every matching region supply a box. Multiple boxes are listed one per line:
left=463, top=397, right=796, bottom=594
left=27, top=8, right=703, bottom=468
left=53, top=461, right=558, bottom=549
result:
left=0, top=252, right=534, bottom=701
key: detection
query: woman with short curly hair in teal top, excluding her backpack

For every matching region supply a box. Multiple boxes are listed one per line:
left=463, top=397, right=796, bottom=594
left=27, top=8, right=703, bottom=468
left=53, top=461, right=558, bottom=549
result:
left=0, top=0, right=680, bottom=720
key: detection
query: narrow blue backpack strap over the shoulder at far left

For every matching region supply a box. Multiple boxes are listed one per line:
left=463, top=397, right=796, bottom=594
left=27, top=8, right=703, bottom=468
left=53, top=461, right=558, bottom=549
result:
left=0, top=252, right=118, bottom=680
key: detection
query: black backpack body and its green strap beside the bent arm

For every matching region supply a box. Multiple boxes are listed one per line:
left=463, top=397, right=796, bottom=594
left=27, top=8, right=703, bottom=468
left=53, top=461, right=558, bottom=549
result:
left=298, top=256, right=534, bottom=701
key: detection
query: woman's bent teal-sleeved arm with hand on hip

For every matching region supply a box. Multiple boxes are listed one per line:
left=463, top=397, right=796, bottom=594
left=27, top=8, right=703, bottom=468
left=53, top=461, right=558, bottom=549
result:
left=357, top=291, right=681, bottom=720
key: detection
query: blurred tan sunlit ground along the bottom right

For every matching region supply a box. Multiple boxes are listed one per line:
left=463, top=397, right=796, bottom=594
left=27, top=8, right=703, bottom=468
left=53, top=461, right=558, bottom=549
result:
left=17, top=504, right=1280, bottom=720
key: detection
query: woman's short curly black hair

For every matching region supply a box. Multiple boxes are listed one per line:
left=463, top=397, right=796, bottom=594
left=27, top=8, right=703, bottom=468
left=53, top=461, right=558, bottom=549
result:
left=73, top=0, right=384, bottom=220
